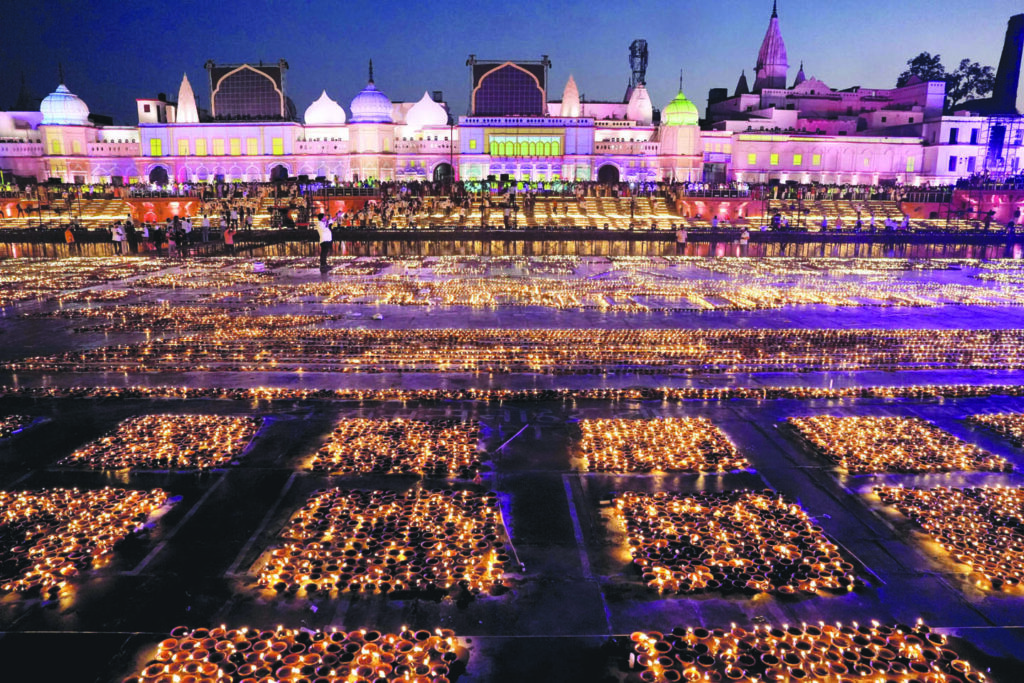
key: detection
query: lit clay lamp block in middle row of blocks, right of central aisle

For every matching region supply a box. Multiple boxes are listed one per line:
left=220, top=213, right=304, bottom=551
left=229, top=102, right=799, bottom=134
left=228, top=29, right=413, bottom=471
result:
left=613, top=490, right=861, bottom=596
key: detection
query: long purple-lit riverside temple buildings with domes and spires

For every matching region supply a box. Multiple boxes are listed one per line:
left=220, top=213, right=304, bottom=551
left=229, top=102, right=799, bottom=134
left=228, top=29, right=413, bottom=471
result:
left=0, top=5, right=1024, bottom=185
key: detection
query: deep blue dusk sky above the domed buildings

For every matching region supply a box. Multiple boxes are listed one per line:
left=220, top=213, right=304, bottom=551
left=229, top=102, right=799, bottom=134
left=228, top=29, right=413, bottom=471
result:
left=0, top=0, right=1024, bottom=124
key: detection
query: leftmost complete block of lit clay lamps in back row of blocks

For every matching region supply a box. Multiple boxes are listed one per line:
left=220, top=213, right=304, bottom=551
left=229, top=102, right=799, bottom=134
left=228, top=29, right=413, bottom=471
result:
left=58, top=415, right=263, bottom=470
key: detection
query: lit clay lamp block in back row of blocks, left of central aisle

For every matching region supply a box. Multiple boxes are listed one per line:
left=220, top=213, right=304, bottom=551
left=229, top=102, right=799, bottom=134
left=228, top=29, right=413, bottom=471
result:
left=310, top=418, right=480, bottom=477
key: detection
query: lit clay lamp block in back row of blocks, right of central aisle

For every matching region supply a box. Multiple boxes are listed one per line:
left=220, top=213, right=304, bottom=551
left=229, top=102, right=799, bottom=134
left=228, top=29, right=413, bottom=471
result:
left=579, top=418, right=751, bottom=473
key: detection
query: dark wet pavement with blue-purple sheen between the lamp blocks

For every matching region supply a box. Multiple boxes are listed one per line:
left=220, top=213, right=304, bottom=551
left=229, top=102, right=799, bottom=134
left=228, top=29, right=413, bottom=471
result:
left=0, top=259, right=1024, bottom=683
